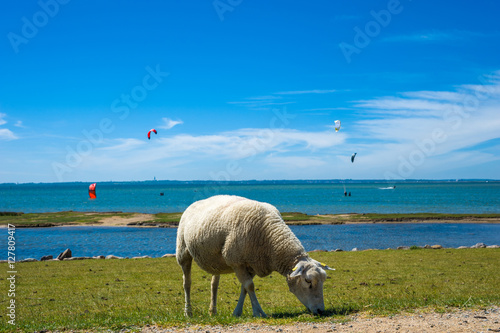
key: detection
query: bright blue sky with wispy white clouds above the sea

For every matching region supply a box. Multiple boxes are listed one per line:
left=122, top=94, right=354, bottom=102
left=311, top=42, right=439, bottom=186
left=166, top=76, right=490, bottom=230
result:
left=0, top=0, right=500, bottom=183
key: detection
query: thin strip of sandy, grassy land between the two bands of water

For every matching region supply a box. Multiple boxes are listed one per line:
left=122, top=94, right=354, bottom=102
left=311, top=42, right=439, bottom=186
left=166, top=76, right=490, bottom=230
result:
left=0, top=211, right=500, bottom=228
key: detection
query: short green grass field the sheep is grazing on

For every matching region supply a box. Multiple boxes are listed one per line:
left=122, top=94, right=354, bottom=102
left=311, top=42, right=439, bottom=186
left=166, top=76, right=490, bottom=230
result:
left=0, top=249, right=500, bottom=332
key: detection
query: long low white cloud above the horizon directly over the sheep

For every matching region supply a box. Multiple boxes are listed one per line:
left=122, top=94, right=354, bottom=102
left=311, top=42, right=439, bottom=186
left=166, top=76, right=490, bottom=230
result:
left=82, top=128, right=345, bottom=178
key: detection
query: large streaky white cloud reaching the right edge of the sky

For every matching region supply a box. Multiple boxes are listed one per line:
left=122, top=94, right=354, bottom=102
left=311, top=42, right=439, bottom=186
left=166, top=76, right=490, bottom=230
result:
left=347, top=76, right=500, bottom=178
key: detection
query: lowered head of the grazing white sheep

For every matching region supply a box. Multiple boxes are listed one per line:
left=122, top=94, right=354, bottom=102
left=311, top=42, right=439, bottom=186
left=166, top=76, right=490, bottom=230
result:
left=286, top=260, right=333, bottom=314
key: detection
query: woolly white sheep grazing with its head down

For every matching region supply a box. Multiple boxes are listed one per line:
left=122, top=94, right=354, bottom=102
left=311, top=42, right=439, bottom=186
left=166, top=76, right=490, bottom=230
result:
left=176, top=195, right=331, bottom=317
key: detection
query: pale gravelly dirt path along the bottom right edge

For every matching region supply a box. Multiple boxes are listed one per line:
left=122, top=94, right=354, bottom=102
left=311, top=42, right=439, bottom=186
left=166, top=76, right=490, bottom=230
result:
left=142, top=307, right=500, bottom=333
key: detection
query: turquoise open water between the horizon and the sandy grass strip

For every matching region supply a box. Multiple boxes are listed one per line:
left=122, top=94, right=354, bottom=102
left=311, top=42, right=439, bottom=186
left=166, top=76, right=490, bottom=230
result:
left=0, top=181, right=500, bottom=214
